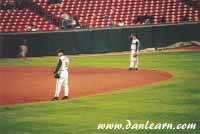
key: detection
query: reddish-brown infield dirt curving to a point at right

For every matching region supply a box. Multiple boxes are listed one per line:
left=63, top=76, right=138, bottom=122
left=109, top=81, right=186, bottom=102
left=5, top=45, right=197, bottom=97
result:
left=0, top=67, right=171, bottom=105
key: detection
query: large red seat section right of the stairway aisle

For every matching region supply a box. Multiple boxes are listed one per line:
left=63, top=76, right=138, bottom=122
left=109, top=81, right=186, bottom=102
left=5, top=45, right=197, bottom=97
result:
left=33, top=0, right=200, bottom=28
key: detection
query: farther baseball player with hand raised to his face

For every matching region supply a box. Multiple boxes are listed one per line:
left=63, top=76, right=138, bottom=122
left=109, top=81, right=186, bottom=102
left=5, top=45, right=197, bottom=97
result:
left=129, top=33, right=140, bottom=71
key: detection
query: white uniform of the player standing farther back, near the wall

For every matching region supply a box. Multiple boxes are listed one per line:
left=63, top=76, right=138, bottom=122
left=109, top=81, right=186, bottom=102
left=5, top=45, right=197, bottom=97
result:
left=129, top=39, right=140, bottom=68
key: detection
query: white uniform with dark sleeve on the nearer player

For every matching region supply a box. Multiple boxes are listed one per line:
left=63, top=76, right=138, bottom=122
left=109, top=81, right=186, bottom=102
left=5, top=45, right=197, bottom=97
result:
left=55, top=55, right=69, bottom=97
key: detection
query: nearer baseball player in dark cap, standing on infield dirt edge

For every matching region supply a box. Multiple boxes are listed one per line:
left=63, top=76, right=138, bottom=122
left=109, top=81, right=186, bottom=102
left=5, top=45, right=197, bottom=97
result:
left=52, top=49, right=69, bottom=101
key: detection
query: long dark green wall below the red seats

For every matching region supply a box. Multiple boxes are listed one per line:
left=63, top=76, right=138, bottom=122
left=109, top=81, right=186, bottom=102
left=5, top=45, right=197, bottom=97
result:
left=0, top=22, right=200, bottom=57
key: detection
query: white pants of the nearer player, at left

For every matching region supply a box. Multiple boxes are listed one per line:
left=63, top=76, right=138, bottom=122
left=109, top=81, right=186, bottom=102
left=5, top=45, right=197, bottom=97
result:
left=55, top=70, right=69, bottom=97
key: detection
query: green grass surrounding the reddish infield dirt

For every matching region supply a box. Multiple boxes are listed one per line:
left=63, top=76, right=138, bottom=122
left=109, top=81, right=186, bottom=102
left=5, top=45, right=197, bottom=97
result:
left=0, top=52, right=200, bottom=134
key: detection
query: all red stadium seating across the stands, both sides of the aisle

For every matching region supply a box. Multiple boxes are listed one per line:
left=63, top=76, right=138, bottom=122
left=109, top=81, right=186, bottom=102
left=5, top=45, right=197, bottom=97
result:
left=0, top=0, right=200, bottom=32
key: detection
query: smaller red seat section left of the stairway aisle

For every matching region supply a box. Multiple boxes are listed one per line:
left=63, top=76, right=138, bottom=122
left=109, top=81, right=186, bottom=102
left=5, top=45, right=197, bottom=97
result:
left=0, top=9, right=60, bottom=32
